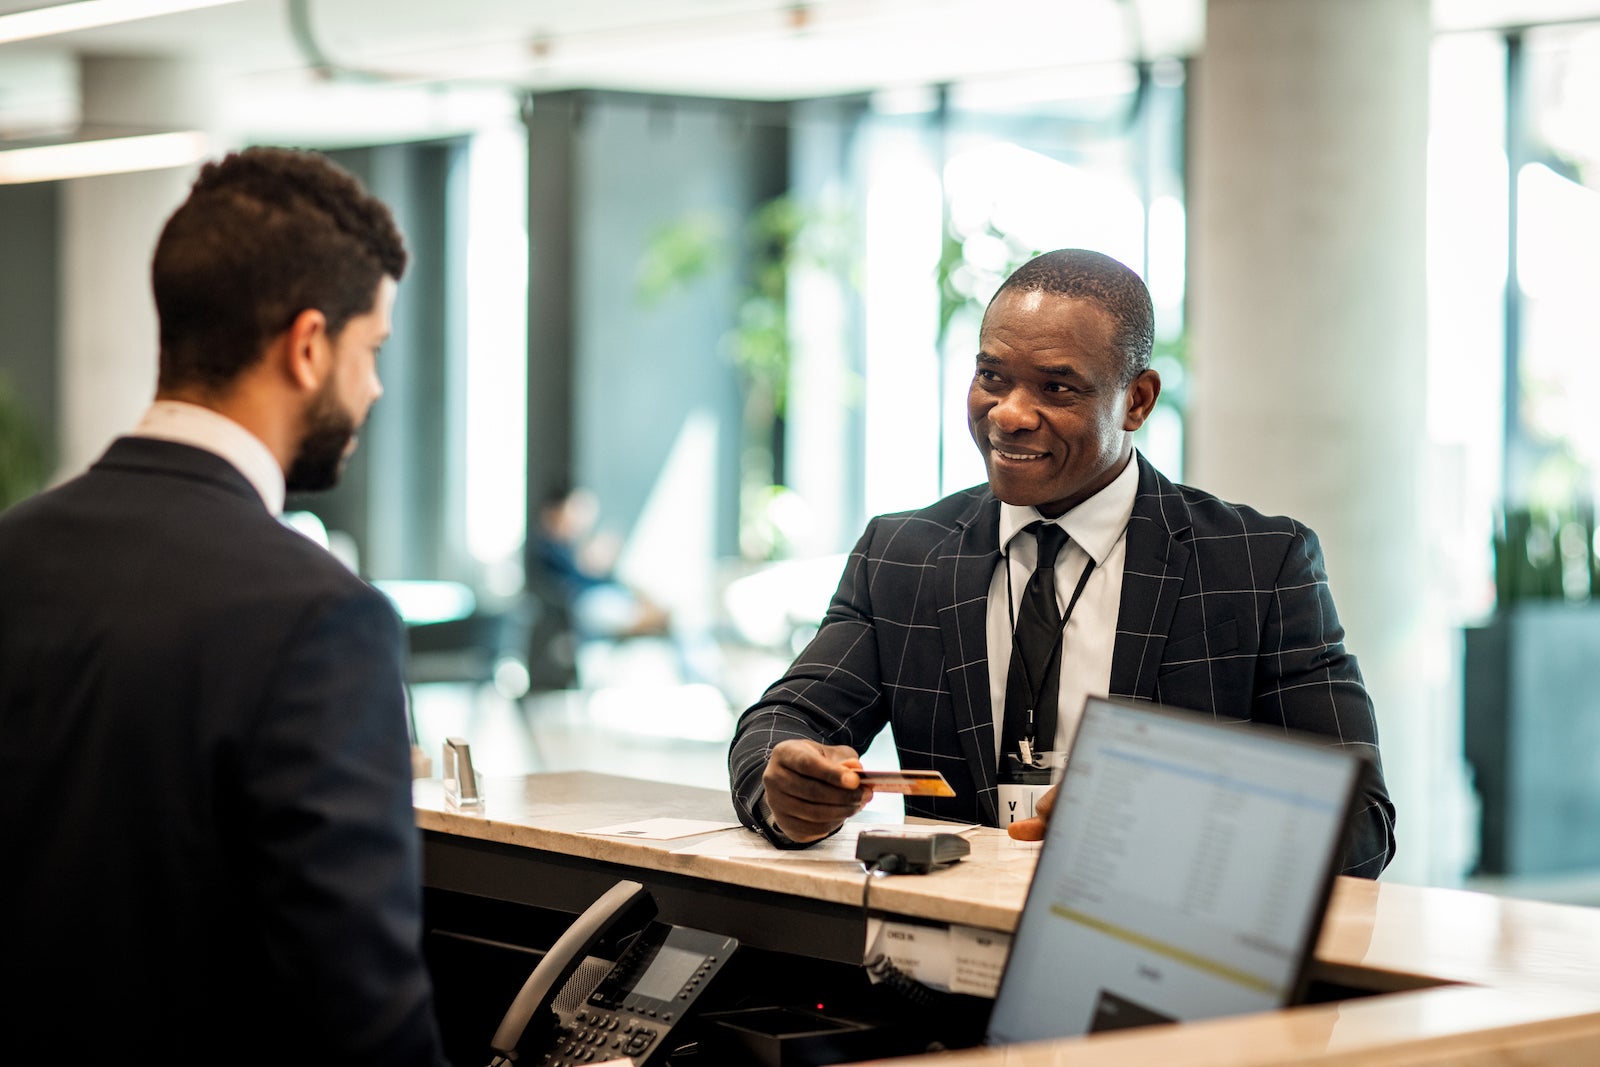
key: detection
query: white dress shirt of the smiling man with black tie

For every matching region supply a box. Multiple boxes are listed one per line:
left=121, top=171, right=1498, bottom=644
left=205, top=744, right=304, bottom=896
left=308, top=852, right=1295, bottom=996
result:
left=987, top=458, right=1139, bottom=771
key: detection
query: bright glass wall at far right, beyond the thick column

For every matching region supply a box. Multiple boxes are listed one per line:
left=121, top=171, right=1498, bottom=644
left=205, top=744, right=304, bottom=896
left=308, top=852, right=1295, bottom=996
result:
left=1427, top=26, right=1600, bottom=619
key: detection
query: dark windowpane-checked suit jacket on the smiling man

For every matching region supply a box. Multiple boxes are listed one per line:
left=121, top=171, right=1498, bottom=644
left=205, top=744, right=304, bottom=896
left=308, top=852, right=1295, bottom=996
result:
left=728, top=456, right=1394, bottom=877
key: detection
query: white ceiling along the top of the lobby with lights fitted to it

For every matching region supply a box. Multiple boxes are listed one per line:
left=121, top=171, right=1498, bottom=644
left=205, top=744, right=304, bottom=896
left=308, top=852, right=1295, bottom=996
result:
left=0, top=0, right=1600, bottom=142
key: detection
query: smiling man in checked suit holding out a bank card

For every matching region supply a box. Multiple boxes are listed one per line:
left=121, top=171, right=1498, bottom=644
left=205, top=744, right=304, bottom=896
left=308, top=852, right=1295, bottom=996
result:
left=728, top=248, right=1394, bottom=878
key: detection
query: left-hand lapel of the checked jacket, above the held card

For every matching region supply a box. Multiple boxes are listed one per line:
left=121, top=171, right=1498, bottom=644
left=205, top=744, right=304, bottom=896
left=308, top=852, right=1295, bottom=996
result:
left=938, top=493, right=1000, bottom=825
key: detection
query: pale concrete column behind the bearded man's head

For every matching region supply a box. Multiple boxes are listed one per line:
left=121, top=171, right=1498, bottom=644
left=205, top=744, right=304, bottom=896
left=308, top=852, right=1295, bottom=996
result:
left=58, top=56, right=216, bottom=477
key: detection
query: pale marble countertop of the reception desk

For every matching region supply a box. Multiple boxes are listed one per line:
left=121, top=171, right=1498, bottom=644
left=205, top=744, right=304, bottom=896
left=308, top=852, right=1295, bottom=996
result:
left=414, top=771, right=1600, bottom=1067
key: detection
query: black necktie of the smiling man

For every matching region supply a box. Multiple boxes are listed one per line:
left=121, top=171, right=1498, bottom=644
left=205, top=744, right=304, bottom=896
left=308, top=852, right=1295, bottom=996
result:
left=1000, top=523, right=1067, bottom=766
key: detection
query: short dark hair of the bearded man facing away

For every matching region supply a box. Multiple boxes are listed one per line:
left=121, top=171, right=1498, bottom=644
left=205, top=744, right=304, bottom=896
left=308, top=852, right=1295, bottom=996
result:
left=150, top=147, right=406, bottom=389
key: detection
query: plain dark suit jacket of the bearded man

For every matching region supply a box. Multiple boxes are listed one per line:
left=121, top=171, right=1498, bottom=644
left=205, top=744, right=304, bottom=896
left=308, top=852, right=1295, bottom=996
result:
left=0, top=438, right=443, bottom=1065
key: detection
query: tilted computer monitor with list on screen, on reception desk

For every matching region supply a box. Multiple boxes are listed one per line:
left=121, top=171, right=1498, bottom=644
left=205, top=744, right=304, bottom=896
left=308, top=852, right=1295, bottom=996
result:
left=986, top=699, right=1362, bottom=1045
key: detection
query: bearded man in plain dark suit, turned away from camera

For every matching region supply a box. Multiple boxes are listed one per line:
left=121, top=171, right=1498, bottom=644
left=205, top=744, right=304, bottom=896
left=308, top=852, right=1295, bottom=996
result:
left=0, top=149, right=443, bottom=1067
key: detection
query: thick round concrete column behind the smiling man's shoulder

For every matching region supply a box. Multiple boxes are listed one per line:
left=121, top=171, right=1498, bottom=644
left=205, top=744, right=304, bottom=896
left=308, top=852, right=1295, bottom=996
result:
left=1186, top=0, right=1461, bottom=881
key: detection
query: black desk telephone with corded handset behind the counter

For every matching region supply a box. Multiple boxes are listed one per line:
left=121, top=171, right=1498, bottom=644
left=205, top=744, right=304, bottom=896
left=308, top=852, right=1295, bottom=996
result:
left=490, top=881, right=739, bottom=1067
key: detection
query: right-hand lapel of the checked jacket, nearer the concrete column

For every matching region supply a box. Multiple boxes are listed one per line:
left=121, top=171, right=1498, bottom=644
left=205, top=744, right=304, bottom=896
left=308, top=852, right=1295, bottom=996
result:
left=1110, top=453, right=1190, bottom=701
